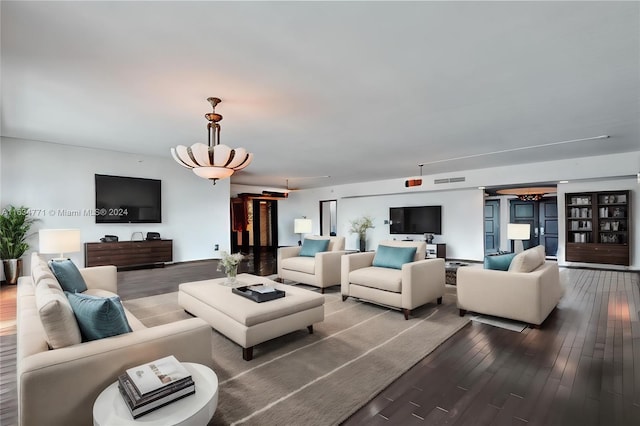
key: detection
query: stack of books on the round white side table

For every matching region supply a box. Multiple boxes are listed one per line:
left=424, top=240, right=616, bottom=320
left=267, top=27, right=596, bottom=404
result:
left=118, top=355, right=196, bottom=419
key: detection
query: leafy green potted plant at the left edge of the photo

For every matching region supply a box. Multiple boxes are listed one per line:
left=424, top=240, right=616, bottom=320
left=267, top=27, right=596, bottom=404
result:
left=0, top=206, right=34, bottom=284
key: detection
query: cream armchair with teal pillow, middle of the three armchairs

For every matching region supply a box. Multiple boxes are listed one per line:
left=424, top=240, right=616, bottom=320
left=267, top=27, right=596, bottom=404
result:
left=341, top=241, right=445, bottom=319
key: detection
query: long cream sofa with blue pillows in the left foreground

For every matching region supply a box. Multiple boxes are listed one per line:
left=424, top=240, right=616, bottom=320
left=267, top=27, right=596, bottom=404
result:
left=16, top=254, right=212, bottom=426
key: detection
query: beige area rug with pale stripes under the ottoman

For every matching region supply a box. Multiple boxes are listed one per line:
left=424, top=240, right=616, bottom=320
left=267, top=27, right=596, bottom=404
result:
left=124, top=287, right=469, bottom=426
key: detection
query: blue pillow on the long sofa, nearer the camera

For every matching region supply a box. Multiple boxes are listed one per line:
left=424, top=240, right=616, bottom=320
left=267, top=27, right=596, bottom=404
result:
left=64, top=291, right=131, bottom=342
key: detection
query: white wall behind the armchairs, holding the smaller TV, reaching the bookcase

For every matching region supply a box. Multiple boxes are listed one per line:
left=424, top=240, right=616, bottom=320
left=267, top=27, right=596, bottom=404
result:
left=278, top=152, right=640, bottom=270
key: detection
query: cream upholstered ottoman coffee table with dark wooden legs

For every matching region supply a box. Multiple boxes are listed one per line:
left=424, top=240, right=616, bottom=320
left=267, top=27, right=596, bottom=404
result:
left=178, top=274, right=324, bottom=361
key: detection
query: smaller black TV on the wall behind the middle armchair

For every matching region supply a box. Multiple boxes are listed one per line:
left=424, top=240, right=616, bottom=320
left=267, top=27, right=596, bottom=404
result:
left=389, top=206, right=442, bottom=234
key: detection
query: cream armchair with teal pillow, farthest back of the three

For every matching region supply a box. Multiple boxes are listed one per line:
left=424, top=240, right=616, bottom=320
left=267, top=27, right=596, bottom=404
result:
left=278, top=235, right=345, bottom=293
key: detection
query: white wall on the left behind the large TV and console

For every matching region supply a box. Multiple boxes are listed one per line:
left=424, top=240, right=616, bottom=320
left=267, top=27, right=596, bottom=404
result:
left=0, top=138, right=230, bottom=271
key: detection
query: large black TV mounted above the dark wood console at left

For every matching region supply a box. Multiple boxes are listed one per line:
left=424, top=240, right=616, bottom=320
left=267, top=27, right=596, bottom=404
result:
left=95, top=175, right=162, bottom=223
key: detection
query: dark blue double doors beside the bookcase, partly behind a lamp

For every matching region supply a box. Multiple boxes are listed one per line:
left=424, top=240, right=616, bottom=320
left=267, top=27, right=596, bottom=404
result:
left=509, top=197, right=558, bottom=257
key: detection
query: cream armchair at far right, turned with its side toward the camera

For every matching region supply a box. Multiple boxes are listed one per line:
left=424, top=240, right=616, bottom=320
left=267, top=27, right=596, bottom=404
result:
left=457, top=246, right=564, bottom=326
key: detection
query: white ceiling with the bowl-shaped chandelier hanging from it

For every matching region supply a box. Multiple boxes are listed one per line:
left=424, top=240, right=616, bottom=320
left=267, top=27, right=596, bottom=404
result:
left=0, top=0, right=640, bottom=187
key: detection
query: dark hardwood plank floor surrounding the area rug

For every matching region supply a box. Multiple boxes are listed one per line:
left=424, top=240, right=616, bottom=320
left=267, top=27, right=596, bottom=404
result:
left=0, top=255, right=640, bottom=426
